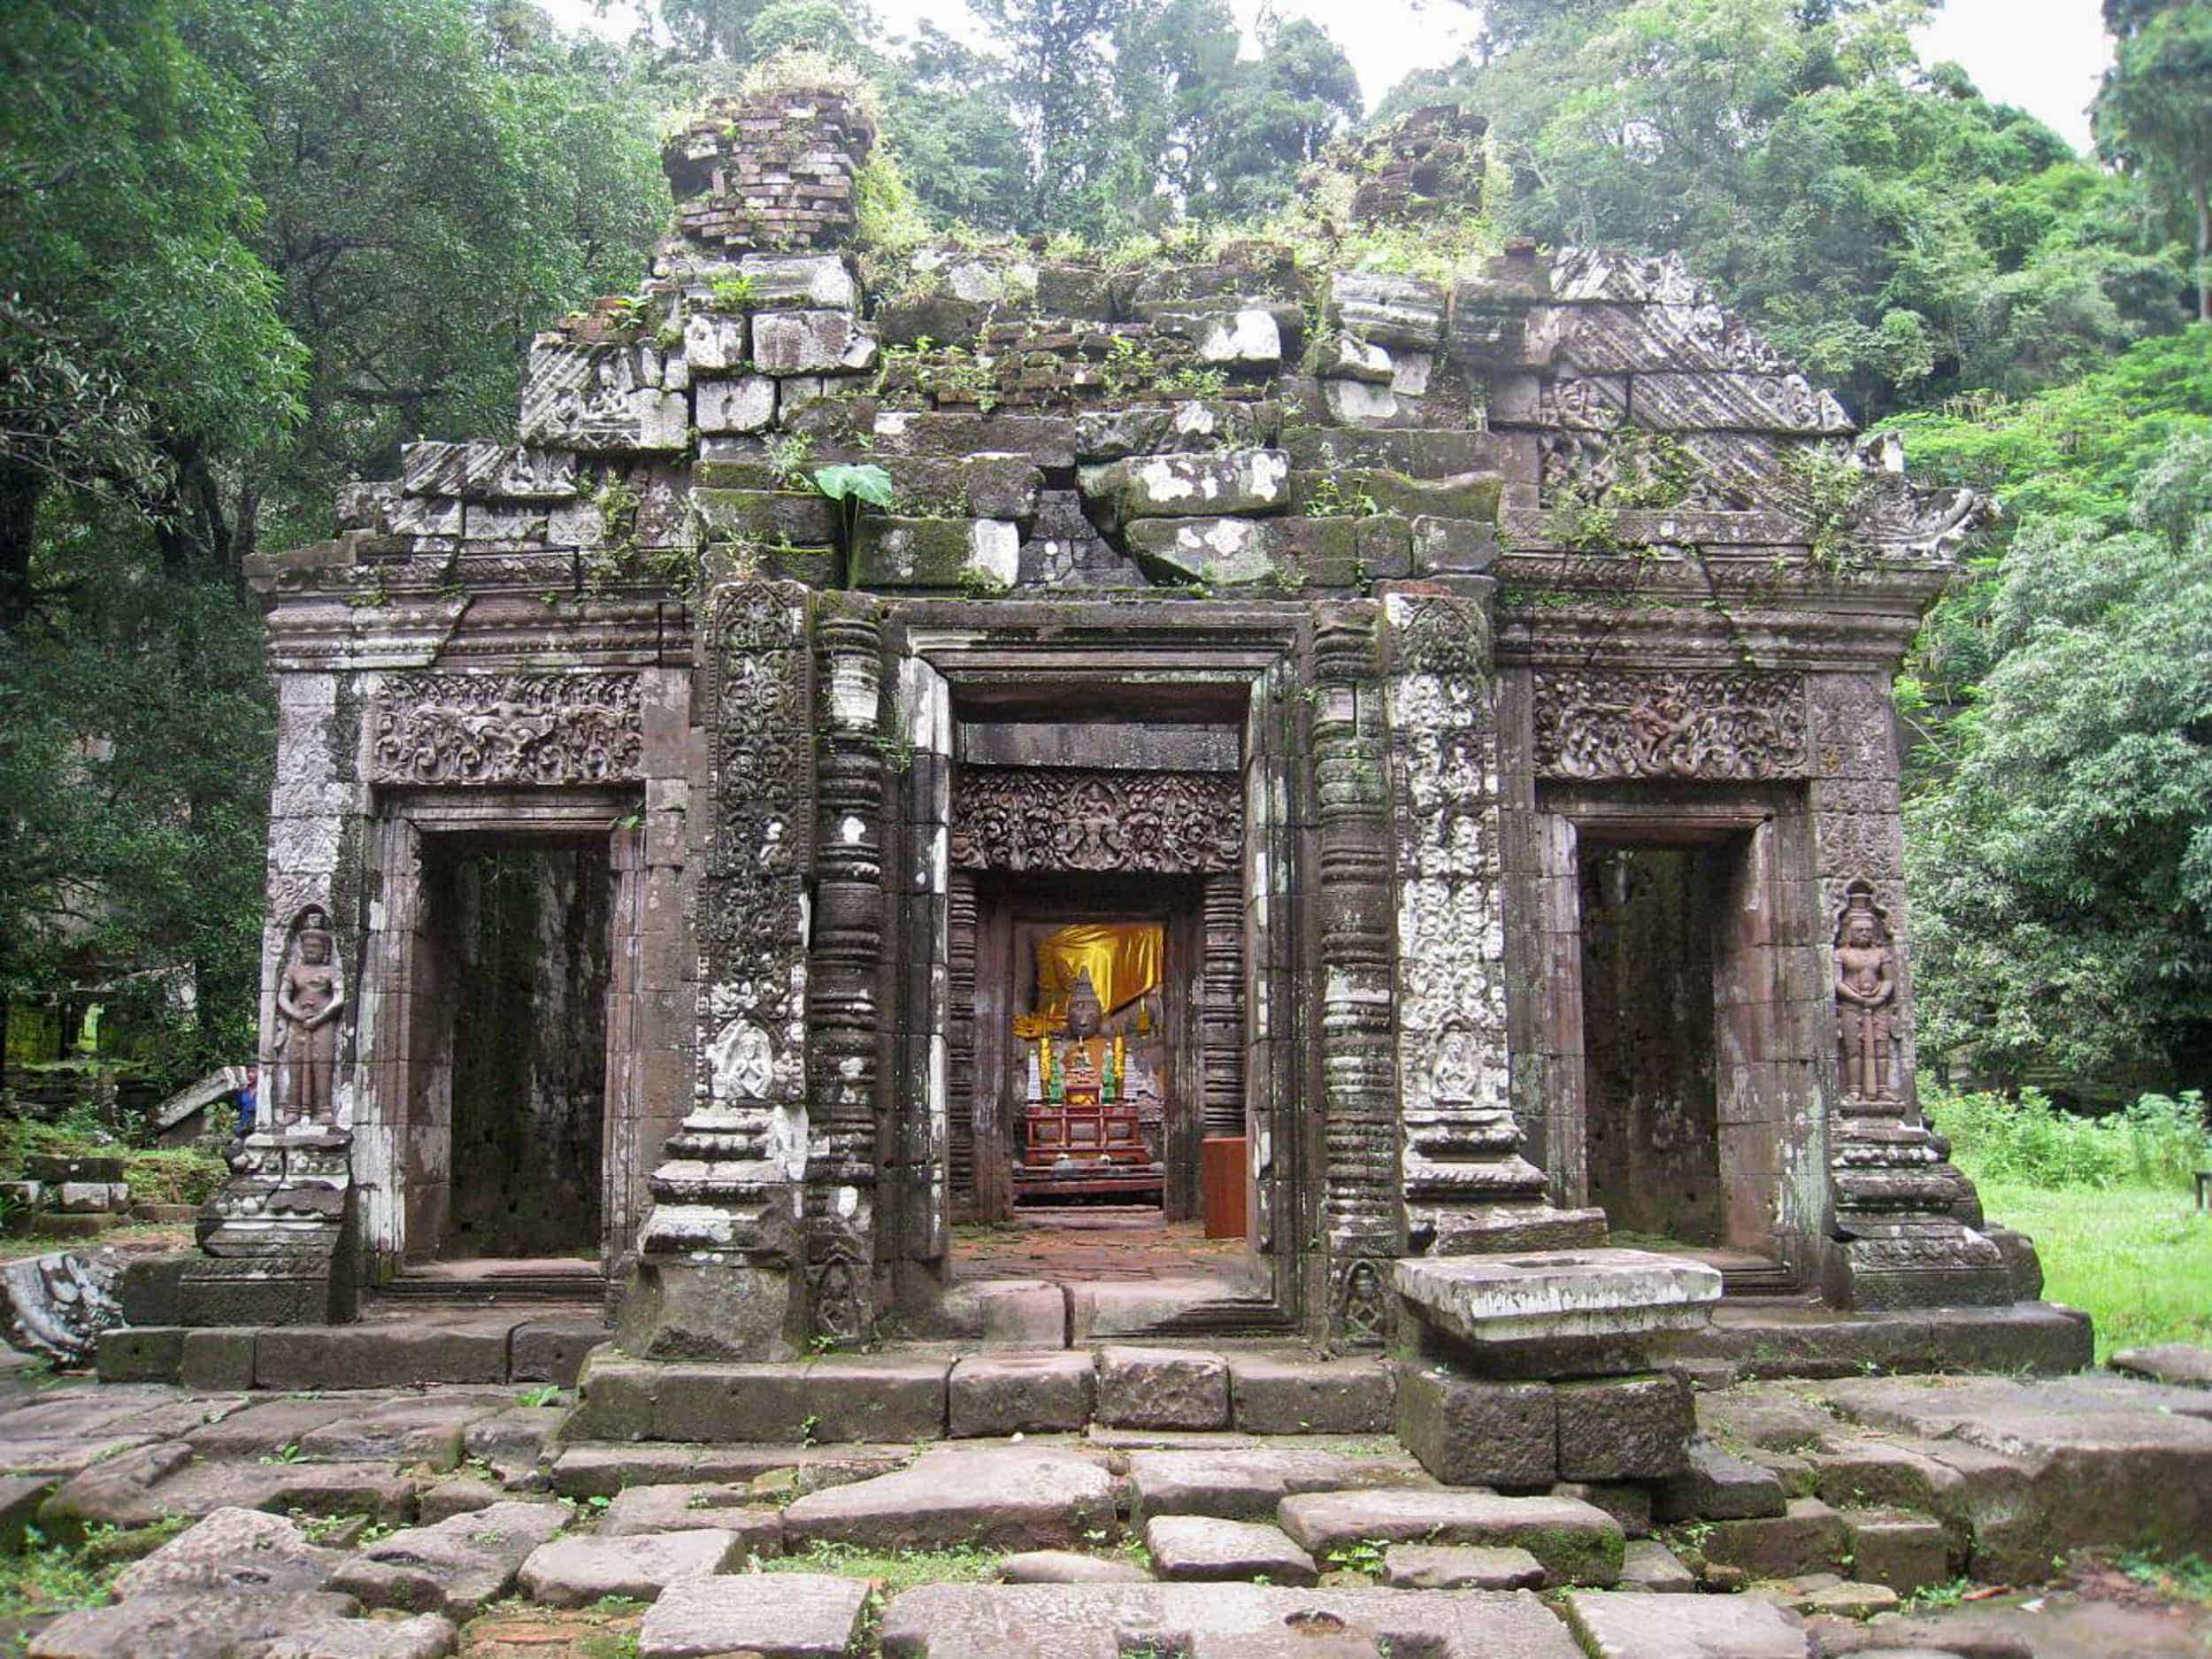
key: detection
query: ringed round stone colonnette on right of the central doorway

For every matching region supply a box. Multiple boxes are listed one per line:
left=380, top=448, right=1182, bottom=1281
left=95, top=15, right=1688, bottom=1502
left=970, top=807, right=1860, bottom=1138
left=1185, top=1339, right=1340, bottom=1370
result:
left=1312, top=604, right=1405, bottom=1348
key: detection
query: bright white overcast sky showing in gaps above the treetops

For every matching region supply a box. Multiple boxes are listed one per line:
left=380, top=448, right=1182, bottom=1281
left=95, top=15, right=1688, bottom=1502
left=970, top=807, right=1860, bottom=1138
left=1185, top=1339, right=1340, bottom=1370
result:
left=542, top=0, right=2113, bottom=149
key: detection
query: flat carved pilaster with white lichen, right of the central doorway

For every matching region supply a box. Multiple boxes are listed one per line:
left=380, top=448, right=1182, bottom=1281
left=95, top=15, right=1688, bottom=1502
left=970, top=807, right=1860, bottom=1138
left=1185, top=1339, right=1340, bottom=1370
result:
left=1385, top=593, right=1604, bottom=1256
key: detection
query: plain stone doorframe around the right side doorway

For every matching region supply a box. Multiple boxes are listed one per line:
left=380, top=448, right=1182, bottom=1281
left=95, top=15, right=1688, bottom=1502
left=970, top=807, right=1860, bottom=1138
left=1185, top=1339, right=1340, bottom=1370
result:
left=1517, top=781, right=1834, bottom=1283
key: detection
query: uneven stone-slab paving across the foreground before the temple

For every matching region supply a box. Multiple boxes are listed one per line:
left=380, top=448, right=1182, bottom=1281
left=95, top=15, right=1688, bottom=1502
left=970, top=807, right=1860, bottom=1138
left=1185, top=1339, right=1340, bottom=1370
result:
left=0, top=1374, right=2212, bottom=1659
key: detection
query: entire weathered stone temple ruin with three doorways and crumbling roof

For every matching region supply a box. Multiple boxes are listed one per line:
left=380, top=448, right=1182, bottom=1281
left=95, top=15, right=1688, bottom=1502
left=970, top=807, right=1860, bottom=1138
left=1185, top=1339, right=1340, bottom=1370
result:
left=138, top=78, right=2082, bottom=1374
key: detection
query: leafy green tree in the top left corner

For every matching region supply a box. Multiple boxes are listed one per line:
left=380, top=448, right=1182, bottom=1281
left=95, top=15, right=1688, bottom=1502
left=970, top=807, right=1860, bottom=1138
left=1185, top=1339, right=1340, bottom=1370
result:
left=0, top=0, right=301, bottom=633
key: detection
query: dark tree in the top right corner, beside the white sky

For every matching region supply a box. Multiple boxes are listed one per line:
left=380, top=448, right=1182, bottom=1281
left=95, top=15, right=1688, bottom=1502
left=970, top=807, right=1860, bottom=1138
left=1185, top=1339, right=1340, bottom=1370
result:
left=2097, top=0, right=2212, bottom=321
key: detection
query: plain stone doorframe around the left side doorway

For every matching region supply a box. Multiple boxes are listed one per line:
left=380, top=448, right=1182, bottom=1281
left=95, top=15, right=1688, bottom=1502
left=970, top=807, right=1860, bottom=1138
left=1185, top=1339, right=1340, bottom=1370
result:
left=352, top=786, right=650, bottom=1283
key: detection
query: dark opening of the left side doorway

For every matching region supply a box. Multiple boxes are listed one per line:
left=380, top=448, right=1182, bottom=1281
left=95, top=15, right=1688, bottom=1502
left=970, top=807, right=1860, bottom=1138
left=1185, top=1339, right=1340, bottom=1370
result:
left=427, top=836, right=613, bottom=1261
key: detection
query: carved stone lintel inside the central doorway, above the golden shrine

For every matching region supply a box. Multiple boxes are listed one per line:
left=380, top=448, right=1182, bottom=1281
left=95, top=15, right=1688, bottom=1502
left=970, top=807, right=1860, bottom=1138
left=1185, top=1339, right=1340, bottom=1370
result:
left=951, top=765, right=1243, bottom=876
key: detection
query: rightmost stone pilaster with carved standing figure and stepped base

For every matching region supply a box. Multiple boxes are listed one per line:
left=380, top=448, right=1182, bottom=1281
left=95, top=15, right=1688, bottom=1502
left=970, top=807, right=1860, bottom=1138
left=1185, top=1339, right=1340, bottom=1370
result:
left=1809, top=675, right=2033, bottom=1310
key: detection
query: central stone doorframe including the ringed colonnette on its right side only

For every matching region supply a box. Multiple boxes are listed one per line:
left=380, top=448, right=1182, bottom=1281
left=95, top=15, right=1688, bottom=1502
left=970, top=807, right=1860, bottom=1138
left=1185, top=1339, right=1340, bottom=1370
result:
left=879, top=600, right=1405, bottom=1340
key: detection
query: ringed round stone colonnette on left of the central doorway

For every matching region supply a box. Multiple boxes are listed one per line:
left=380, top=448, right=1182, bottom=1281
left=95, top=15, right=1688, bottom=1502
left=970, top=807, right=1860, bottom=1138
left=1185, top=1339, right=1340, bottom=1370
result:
left=805, top=593, right=885, bottom=1343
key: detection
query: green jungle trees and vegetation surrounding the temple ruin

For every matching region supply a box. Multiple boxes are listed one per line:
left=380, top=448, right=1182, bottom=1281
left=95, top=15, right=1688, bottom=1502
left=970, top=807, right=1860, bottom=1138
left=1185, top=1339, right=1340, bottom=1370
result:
left=0, top=0, right=2212, bottom=1340
